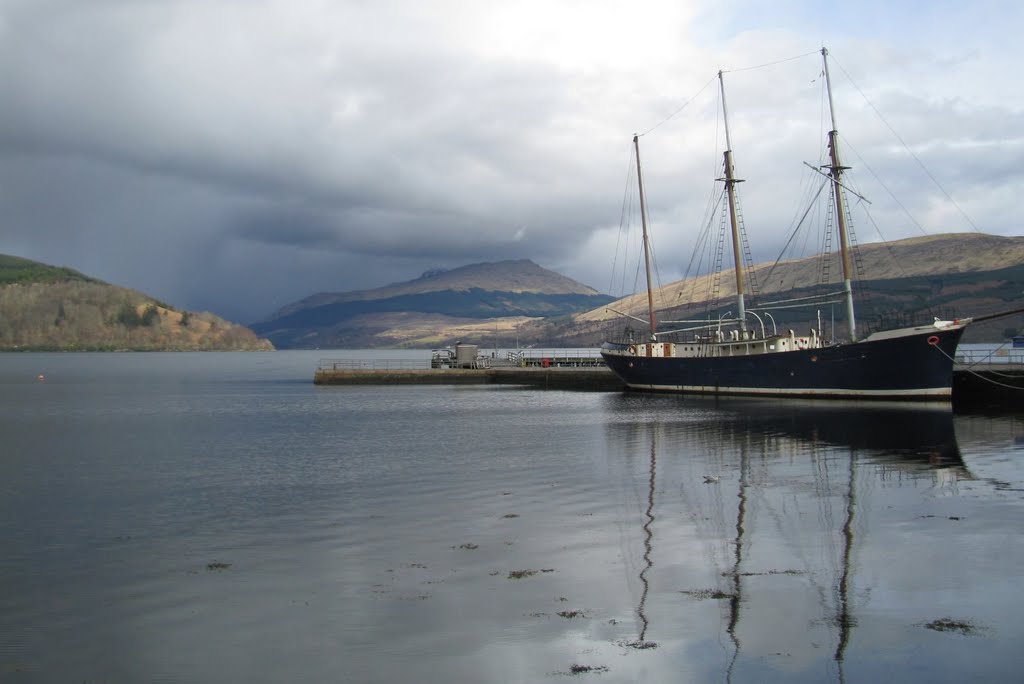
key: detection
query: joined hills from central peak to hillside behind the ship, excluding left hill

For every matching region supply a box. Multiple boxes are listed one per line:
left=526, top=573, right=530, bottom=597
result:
left=252, top=233, right=1024, bottom=348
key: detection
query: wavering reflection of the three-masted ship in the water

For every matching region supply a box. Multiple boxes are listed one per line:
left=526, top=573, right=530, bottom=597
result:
left=606, top=395, right=970, bottom=681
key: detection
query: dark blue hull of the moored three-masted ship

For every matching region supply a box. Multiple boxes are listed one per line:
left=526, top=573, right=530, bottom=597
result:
left=601, top=325, right=965, bottom=399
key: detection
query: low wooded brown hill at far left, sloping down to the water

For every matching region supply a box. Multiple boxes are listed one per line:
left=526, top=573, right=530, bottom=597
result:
left=0, top=254, right=273, bottom=351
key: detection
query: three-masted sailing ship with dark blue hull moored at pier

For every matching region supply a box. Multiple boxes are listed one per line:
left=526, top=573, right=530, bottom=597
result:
left=601, top=48, right=972, bottom=399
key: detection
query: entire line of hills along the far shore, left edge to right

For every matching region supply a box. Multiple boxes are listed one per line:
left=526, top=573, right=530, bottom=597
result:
left=0, top=233, right=1024, bottom=350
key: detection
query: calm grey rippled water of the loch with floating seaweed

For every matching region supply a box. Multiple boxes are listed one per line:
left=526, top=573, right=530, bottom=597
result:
left=0, top=352, right=1024, bottom=684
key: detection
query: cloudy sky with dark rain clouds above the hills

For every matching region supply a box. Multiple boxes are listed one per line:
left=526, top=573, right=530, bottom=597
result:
left=0, top=0, right=1024, bottom=324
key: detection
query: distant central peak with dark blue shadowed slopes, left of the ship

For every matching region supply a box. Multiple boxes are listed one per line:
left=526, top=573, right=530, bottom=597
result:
left=251, top=259, right=612, bottom=348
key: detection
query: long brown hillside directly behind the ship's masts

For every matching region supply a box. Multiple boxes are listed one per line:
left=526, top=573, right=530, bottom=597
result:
left=561, top=233, right=1024, bottom=346
